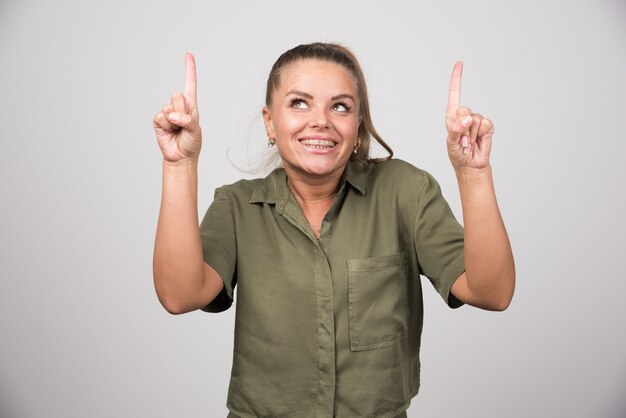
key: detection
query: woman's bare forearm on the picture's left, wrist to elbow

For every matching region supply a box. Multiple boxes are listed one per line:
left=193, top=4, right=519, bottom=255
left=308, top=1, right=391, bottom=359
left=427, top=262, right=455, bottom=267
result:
left=153, top=159, right=204, bottom=313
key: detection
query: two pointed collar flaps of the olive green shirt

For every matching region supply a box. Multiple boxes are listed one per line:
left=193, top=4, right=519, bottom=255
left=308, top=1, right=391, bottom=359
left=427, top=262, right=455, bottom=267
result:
left=249, top=160, right=373, bottom=204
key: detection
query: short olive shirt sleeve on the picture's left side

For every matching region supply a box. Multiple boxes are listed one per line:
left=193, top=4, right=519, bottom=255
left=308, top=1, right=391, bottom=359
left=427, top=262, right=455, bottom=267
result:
left=200, top=188, right=237, bottom=312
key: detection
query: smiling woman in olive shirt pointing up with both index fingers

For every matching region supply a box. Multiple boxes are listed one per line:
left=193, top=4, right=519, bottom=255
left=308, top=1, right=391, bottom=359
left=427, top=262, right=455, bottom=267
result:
left=154, top=43, right=515, bottom=417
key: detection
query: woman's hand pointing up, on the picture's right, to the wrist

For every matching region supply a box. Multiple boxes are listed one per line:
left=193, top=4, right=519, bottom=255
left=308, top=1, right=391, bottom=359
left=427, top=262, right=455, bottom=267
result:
left=446, top=62, right=493, bottom=171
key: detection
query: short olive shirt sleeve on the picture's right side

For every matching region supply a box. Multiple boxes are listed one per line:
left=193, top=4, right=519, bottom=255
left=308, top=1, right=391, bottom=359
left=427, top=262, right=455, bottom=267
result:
left=414, top=172, right=465, bottom=308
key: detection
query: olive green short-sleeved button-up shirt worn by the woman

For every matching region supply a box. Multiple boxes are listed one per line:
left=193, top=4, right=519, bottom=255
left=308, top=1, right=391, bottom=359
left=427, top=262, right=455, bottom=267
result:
left=201, top=160, right=464, bottom=418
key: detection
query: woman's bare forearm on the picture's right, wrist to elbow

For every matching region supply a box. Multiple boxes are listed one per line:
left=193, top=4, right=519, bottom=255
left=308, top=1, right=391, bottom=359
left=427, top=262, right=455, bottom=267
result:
left=456, top=165, right=515, bottom=310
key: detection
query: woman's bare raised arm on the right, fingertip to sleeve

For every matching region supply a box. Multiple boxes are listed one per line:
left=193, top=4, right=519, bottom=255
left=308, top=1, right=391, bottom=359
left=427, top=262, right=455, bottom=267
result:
left=446, top=62, right=515, bottom=310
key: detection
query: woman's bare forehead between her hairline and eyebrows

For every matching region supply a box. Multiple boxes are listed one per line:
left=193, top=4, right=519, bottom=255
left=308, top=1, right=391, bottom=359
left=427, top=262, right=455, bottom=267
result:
left=277, top=59, right=357, bottom=94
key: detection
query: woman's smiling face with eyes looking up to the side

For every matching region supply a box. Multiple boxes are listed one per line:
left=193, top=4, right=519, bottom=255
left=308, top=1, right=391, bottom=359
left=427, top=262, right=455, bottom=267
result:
left=263, top=59, right=361, bottom=178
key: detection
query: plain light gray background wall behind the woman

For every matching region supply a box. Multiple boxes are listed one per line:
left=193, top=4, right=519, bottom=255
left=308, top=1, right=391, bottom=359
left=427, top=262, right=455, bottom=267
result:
left=0, top=0, right=626, bottom=418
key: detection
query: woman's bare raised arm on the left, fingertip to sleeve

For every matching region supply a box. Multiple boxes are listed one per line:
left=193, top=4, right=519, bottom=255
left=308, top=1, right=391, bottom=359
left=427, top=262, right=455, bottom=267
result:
left=152, top=54, right=223, bottom=314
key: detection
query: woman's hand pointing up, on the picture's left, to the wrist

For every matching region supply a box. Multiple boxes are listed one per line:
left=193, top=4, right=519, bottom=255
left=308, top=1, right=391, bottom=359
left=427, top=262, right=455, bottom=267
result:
left=152, top=53, right=202, bottom=162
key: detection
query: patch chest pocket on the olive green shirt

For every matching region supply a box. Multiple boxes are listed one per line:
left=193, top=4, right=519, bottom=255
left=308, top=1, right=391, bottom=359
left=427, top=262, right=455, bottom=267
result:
left=348, top=253, right=408, bottom=351
